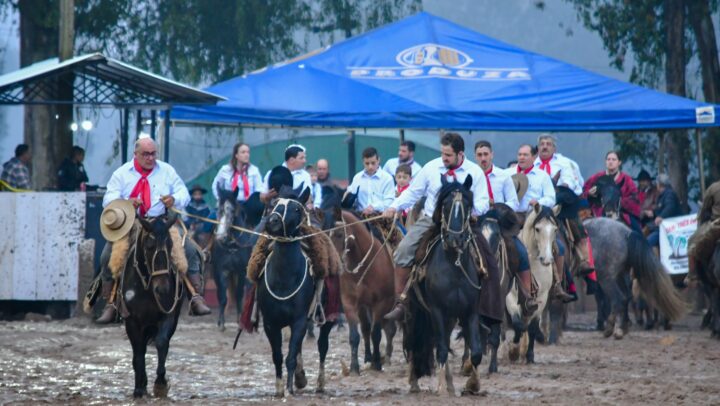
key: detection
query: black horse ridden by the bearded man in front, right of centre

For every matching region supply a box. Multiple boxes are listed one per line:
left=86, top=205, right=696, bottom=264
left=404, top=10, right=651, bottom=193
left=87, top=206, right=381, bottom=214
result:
left=403, top=175, right=482, bottom=396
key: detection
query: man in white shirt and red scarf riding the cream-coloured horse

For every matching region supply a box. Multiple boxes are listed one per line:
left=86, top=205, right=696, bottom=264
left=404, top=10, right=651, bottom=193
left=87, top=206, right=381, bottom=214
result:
left=517, top=144, right=582, bottom=301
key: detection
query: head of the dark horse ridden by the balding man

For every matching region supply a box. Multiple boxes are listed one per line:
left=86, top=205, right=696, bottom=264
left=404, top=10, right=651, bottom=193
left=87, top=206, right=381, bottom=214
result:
left=137, top=212, right=178, bottom=293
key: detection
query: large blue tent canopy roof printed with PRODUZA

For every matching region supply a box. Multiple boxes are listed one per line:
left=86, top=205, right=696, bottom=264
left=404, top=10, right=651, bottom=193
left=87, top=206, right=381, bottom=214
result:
left=171, top=13, right=717, bottom=131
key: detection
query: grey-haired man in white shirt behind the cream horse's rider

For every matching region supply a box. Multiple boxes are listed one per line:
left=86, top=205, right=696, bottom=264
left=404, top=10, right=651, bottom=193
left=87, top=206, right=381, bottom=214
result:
left=534, top=133, right=585, bottom=196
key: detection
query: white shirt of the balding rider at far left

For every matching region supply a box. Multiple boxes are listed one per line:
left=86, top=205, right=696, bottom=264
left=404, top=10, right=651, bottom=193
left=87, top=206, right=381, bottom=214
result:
left=103, top=160, right=190, bottom=217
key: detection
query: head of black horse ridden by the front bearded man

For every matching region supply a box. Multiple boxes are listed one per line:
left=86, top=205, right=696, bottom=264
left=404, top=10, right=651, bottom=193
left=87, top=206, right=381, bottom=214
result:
left=433, top=175, right=473, bottom=249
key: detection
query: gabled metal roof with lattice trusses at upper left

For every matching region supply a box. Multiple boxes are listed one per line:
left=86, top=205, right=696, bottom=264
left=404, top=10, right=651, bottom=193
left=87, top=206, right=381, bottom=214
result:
left=0, top=53, right=226, bottom=109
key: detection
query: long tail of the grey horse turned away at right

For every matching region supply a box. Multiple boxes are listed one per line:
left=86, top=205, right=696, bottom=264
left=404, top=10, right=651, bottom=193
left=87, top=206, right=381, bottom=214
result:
left=628, top=231, right=687, bottom=320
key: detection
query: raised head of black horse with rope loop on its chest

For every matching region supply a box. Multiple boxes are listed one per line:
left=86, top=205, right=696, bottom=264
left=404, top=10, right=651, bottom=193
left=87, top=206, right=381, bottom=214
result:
left=265, top=184, right=310, bottom=237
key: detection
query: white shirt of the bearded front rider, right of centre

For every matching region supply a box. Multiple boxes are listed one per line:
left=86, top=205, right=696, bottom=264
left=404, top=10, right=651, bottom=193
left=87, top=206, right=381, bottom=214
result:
left=390, top=158, right=490, bottom=216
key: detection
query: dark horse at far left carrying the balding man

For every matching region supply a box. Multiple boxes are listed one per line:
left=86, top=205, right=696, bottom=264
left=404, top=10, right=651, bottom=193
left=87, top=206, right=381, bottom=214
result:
left=120, top=213, right=183, bottom=398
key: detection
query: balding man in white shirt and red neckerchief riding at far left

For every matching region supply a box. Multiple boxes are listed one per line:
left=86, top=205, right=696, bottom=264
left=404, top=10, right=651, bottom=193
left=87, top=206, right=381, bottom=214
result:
left=96, top=138, right=210, bottom=324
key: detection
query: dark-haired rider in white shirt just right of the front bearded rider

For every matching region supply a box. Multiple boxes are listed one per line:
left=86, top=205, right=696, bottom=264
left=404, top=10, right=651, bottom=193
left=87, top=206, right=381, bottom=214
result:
left=475, top=141, right=538, bottom=314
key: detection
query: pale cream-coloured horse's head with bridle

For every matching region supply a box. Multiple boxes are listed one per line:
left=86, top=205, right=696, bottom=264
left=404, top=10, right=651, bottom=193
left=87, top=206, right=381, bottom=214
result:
left=523, top=204, right=560, bottom=266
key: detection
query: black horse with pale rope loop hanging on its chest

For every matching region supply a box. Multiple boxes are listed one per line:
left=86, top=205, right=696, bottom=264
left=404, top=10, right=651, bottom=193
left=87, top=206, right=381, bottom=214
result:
left=257, top=185, right=334, bottom=397
